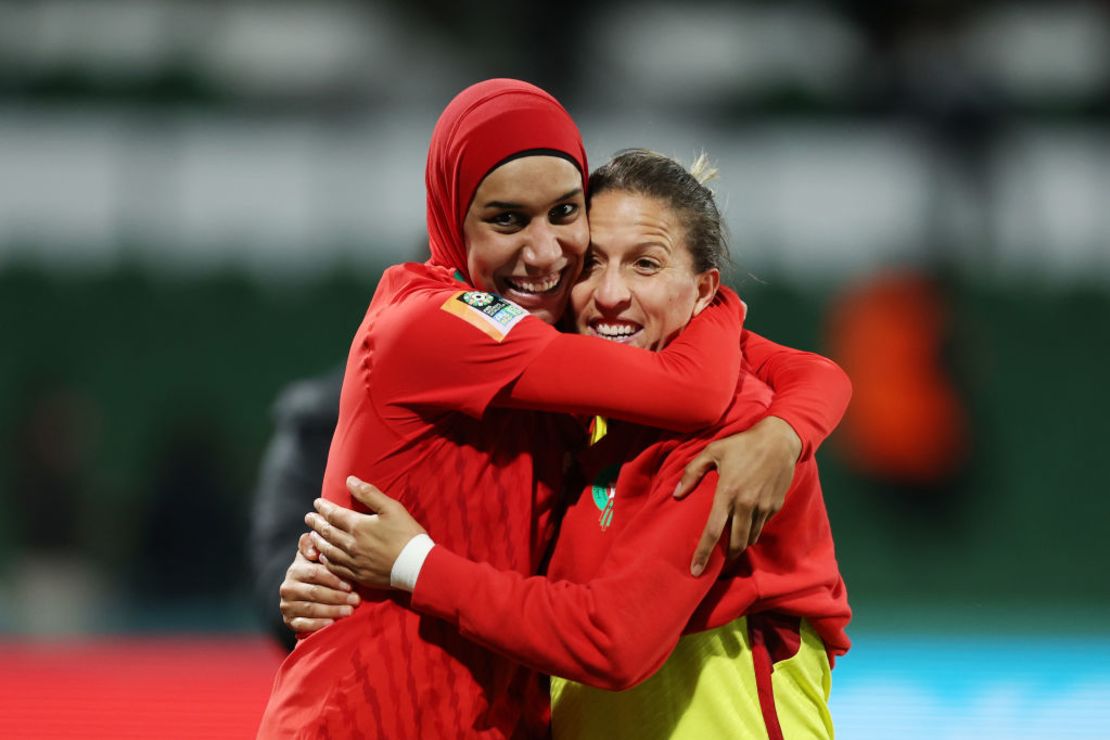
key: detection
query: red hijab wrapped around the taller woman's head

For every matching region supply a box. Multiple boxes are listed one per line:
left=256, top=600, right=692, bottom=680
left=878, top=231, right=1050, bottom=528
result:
left=424, top=80, right=589, bottom=283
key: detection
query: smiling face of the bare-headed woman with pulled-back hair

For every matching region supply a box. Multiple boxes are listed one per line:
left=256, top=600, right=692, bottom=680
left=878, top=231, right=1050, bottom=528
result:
left=571, top=191, right=720, bottom=351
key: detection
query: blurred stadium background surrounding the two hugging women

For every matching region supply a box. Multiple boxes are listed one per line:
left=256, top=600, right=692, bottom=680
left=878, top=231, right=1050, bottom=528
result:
left=0, top=0, right=1110, bottom=739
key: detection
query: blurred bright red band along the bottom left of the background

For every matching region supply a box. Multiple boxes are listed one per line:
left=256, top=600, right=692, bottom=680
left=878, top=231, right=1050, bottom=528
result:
left=0, top=637, right=283, bottom=740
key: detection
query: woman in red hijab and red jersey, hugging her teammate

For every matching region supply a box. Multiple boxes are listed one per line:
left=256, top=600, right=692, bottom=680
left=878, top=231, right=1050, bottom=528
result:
left=260, top=80, right=841, bottom=737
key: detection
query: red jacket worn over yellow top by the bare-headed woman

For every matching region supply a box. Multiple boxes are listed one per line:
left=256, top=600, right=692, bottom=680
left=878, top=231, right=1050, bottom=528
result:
left=412, top=376, right=850, bottom=690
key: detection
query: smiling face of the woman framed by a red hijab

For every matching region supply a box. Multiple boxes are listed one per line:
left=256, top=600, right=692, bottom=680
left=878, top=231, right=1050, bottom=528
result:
left=463, top=155, right=589, bottom=324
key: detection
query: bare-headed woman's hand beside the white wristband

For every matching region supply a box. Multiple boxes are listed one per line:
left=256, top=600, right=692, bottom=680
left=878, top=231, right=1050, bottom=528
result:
left=304, top=476, right=425, bottom=588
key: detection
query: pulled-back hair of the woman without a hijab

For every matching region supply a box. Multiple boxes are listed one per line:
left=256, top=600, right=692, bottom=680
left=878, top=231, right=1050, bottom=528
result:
left=589, top=149, right=729, bottom=273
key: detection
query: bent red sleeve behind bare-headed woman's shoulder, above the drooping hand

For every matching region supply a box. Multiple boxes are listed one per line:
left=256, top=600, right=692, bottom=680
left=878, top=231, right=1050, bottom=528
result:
left=740, top=330, right=851, bottom=462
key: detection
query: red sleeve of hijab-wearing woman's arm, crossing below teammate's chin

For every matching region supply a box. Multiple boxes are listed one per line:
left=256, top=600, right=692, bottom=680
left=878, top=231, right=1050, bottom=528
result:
left=494, top=288, right=744, bottom=432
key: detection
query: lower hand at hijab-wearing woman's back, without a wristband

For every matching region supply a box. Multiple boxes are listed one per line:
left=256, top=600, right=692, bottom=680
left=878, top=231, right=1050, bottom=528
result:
left=279, top=534, right=359, bottom=632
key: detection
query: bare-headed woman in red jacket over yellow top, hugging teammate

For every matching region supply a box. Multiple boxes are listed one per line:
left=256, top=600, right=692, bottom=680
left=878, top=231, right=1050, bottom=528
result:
left=297, top=150, right=850, bottom=738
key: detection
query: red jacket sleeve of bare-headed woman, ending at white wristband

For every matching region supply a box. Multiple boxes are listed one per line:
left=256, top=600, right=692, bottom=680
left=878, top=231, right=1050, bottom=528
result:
left=412, top=458, right=724, bottom=690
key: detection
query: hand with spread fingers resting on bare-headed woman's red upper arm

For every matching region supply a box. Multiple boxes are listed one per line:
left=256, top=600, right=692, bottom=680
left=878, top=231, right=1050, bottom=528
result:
left=675, top=416, right=801, bottom=576
